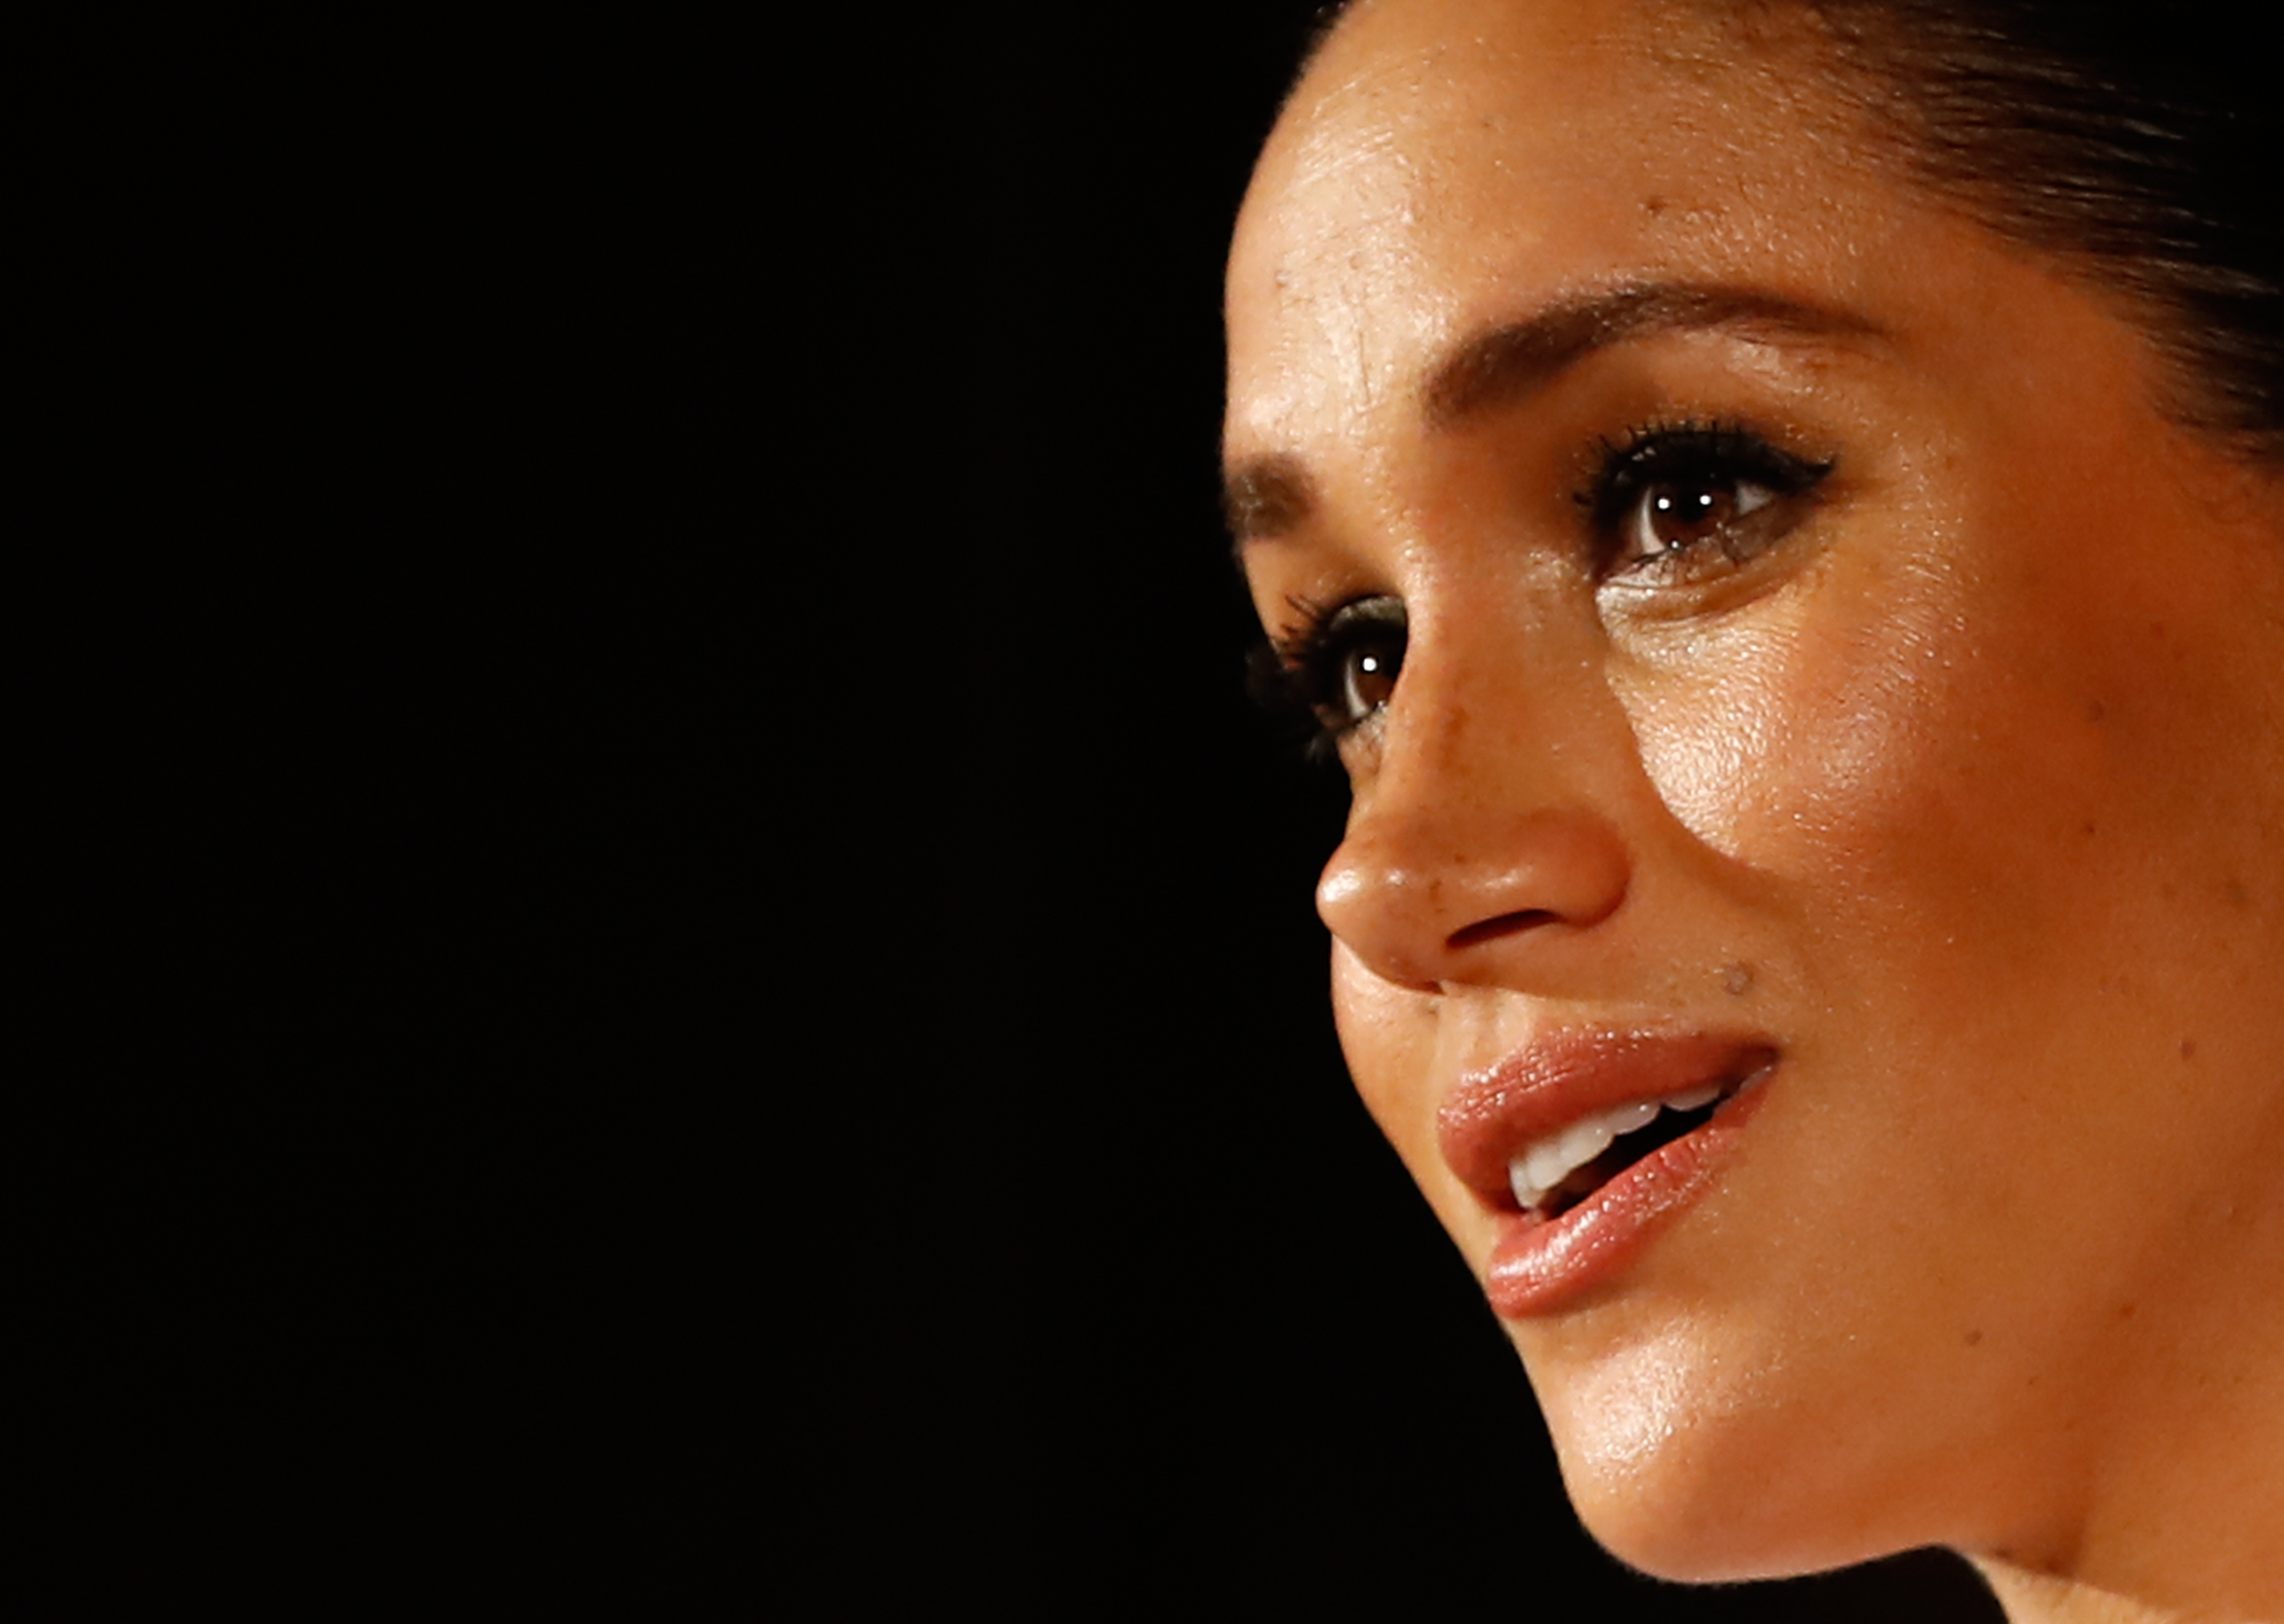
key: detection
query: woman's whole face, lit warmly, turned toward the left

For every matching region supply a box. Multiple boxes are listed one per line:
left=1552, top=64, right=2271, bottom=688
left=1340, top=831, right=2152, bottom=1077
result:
left=1227, top=0, right=2284, bottom=1576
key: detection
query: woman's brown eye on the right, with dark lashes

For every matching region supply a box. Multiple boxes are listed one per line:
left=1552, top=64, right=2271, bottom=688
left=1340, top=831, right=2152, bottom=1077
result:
left=1578, top=422, right=1832, bottom=587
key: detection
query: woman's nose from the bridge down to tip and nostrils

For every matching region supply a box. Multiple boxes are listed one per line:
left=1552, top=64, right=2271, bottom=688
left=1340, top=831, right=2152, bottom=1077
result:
left=1318, top=614, right=1631, bottom=992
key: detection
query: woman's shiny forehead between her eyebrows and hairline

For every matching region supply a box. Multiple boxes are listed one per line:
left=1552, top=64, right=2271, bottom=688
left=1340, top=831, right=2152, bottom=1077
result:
left=1229, top=0, right=1900, bottom=452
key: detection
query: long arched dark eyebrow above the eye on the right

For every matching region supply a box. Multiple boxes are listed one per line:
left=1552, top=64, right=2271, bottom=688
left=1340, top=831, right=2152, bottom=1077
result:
left=1421, top=283, right=1877, bottom=432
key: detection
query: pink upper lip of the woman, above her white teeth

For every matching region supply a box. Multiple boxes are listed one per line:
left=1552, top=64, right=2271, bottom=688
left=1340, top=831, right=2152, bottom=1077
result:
left=1437, top=1028, right=1777, bottom=1213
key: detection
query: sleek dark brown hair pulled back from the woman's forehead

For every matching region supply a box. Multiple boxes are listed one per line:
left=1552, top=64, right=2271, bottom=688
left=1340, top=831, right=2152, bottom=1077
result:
left=1807, top=0, right=2284, bottom=464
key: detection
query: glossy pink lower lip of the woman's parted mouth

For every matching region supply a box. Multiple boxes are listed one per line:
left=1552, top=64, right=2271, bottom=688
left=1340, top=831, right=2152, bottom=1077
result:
left=1485, top=1076, right=1772, bottom=1320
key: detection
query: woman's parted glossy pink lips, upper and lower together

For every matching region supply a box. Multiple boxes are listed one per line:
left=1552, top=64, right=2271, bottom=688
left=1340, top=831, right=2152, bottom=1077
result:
left=1437, top=1030, right=1777, bottom=1318
